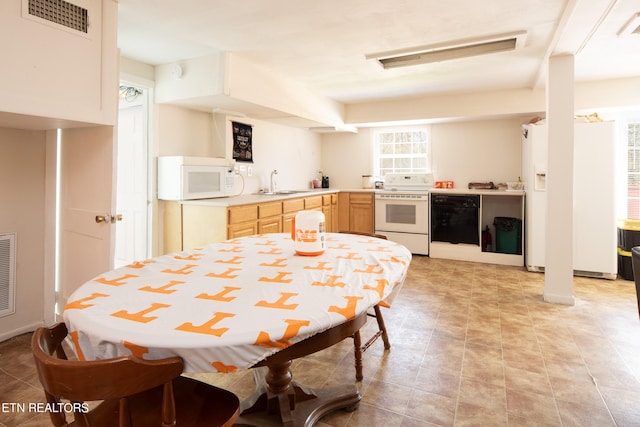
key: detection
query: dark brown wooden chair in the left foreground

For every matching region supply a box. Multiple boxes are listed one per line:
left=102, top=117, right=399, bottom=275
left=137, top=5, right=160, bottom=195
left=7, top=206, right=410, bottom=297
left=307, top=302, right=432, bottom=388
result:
left=31, top=323, right=240, bottom=427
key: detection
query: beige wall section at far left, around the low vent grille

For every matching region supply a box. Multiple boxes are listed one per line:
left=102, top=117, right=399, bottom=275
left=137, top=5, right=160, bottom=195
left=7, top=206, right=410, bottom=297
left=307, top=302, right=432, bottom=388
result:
left=0, top=128, right=46, bottom=341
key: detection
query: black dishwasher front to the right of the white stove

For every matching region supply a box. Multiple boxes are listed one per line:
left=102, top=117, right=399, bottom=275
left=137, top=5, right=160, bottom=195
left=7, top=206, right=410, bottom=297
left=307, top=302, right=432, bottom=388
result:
left=431, top=194, right=480, bottom=245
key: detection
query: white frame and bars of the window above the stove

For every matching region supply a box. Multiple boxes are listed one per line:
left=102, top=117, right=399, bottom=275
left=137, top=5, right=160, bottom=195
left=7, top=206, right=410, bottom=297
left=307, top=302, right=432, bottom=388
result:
left=371, top=125, right=431, bottom=178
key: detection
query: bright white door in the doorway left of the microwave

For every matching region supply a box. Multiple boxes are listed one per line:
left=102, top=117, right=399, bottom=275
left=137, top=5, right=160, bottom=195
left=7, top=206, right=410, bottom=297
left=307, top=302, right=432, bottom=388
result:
left=114, top=103, right=149, bottom=268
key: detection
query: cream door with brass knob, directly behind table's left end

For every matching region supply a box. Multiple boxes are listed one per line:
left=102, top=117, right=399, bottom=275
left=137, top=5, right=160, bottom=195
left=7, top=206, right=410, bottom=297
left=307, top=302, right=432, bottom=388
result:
left=57, top=126, right=115, bottom=313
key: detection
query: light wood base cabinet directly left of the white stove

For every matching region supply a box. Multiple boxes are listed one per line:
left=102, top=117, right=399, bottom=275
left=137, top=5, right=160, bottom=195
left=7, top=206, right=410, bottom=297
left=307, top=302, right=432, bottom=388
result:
left=336, top=192, right=375, bottom=233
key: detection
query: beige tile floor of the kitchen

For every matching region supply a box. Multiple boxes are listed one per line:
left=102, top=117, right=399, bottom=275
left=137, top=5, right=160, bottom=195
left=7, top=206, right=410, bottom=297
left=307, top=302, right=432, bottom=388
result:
left=0, top=256, right=640, bottom=427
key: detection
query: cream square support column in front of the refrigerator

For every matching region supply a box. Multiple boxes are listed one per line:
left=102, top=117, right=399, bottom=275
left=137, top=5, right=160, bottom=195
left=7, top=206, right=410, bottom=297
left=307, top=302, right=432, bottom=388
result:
left=543, top=55, right=575, bottom=305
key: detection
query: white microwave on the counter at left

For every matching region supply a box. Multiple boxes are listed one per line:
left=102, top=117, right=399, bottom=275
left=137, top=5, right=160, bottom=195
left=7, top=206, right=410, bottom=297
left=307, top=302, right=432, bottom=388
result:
left=158, top=156, right=235, bottom=200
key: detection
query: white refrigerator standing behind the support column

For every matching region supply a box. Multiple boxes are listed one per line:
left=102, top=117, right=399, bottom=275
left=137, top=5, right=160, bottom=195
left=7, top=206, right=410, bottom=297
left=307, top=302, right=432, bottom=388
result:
left=522, top=122, right=618, bottom=279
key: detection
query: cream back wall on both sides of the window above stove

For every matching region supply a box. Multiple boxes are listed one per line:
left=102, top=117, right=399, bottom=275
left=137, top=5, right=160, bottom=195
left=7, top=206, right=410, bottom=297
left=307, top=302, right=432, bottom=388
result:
left=322, top=119, right=522, bottom=188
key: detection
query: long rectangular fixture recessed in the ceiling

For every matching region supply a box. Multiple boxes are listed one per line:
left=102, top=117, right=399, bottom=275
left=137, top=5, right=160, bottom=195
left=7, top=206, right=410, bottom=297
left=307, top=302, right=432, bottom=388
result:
left=366, top=31, right=527, bottom=69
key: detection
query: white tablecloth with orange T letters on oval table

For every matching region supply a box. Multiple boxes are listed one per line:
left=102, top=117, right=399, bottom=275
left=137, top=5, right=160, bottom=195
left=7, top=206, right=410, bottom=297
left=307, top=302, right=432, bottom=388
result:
left=63, top=233, right=411, bottom=372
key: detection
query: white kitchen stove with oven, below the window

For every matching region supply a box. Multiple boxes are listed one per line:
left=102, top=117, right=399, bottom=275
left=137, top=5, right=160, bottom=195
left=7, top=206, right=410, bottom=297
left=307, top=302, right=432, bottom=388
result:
left=375, top=173, right=434, bottom=255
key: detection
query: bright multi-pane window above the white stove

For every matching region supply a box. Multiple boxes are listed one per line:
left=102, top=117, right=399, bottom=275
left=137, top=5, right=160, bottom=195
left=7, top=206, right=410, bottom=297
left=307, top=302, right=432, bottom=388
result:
left=373, top=127, right=431, bottom=177
